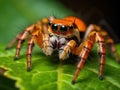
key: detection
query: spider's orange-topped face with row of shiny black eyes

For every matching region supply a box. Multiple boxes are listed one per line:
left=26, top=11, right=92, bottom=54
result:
left=48, top=19, right=74, bottom=36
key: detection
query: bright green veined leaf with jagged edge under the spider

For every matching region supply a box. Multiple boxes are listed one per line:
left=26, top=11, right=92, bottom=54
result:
left=0, top=45, right=120, bottom=90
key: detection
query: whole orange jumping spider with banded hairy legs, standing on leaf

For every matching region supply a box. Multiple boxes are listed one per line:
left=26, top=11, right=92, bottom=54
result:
left=6, top=16, right=119, bottom=84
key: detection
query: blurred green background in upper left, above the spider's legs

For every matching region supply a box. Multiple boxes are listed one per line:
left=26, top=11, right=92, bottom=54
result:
left=0, top=0, right=74, bottom=43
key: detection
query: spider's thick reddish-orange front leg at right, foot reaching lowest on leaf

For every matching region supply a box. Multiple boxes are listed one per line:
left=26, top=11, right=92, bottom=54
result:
left=72, top=31, right=95, bottom=84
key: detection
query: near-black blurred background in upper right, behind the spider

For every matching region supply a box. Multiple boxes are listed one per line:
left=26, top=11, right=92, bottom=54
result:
left=60, top=0, right=120, bottom=43
